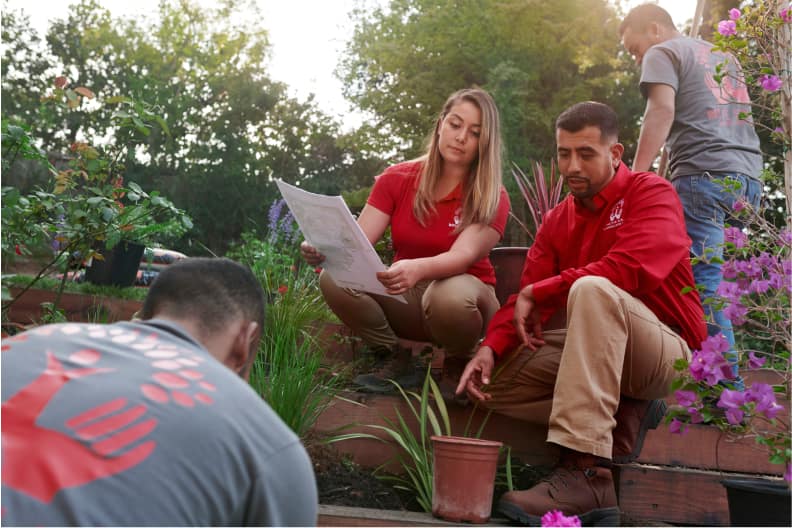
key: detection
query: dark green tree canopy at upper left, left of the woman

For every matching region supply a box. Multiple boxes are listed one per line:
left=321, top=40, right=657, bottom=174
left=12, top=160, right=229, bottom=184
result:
left=2, top=0, right=379, bottom=250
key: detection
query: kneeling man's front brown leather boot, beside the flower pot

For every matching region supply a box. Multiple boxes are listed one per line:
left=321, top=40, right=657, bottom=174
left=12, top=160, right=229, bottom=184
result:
left=498, top=465, right=620, bottom=526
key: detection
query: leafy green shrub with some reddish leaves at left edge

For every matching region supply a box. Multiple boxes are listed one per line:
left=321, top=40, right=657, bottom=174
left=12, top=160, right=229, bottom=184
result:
left=2, top=77, right=192, bottom=316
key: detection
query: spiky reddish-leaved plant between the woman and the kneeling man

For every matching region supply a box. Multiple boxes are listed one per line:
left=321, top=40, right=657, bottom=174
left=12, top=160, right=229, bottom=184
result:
left=511, top=160, right=564, bottom=239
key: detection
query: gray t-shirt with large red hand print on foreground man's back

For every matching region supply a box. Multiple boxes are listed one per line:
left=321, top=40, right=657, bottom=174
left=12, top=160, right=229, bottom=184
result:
left=0, top=321, right=317, bottom=526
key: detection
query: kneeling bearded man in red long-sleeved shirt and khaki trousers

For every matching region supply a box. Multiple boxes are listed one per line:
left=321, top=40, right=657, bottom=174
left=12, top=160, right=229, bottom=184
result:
left=457, top=102, right=707, bottom=525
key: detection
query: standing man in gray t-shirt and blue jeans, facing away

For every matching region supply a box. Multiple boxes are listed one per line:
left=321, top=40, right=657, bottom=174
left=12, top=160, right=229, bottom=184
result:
left=619, top=4, right=762, bottom=387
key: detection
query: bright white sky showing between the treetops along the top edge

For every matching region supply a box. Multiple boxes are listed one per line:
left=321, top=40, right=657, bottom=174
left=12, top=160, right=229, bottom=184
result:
left=8, top=0, right=696, bottom=128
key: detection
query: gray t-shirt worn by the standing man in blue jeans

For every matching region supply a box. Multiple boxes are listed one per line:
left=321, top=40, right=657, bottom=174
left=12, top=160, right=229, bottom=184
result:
left=641, top=36, right=762, bottom=179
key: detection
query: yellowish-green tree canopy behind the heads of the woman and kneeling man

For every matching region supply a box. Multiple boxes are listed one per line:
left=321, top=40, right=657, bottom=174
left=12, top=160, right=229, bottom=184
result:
left=338, top=0, right=643, bottom=166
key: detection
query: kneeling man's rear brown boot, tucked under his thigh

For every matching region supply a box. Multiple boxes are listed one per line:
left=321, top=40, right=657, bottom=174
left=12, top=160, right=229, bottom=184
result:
left=613, top=396, right=668, bottom=464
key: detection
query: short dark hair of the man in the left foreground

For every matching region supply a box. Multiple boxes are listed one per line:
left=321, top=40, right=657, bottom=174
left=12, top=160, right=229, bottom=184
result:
left=140, top=257, right=264, bottom=332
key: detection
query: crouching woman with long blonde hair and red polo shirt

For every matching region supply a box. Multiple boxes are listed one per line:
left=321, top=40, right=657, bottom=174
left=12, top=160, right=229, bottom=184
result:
left=300, top=89, right=509, bottom=392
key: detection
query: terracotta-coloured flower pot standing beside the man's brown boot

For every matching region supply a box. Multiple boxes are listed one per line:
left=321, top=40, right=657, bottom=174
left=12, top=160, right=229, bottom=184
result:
left=431, top=436, right=503, bottom=524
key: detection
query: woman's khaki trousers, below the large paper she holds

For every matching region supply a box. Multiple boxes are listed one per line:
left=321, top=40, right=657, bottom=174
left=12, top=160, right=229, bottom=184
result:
left=319, top=271, right=499, bottom=355
